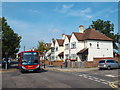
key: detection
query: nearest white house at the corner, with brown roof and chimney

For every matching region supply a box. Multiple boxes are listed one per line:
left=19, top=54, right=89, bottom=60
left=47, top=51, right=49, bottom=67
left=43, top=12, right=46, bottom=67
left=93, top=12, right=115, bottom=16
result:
left=70, top=25, right=113, bottom=61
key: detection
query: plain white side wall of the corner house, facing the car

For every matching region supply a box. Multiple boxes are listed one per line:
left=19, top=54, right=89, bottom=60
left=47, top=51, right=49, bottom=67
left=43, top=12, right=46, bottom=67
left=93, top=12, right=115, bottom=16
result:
left=85, top=40, right=113, bottom=61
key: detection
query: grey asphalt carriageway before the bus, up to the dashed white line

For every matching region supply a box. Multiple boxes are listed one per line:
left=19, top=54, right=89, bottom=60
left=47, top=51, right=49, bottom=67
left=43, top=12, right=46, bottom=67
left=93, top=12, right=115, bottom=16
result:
left=2, top=71, right=115, bottom=88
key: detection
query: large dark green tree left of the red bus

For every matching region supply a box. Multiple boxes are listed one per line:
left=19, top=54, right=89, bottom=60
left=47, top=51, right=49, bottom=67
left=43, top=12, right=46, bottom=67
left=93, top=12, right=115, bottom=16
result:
left=0, top=17, right=21, bottom=58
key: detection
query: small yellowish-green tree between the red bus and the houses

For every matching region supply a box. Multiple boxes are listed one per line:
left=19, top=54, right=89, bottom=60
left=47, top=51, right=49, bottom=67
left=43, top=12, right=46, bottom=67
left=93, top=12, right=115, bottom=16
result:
left=36, top=41, right=50, bottom=56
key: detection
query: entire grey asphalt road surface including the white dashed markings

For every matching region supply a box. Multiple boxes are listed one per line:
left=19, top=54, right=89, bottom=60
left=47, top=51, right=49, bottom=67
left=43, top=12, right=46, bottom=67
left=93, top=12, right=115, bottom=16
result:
left=2, top=60, right=119, bottom=88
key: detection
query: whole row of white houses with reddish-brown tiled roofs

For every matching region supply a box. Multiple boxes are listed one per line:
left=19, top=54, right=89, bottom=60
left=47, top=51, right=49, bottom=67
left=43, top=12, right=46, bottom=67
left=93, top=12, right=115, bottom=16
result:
left=45, top=25, right=113, bottom=61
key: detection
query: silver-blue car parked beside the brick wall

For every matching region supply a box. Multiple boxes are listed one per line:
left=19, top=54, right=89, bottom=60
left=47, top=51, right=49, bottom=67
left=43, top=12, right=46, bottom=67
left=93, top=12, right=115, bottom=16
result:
left=98, top=59, right=120, bottom=70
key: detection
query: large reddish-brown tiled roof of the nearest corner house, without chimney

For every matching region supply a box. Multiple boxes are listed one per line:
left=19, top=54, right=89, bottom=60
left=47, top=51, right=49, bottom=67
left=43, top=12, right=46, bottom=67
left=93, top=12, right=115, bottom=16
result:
left=73, top=29, right=113, bottom=41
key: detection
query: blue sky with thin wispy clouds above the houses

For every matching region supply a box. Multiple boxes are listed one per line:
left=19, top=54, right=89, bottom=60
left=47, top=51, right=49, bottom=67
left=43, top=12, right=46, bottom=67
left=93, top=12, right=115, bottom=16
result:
left=2, top=2, right=118, bottom=51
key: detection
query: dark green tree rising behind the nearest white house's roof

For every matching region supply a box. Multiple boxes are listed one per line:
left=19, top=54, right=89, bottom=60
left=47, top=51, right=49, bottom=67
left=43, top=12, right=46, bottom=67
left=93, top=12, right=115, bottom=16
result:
left=89, top=19, right=120, bottom=50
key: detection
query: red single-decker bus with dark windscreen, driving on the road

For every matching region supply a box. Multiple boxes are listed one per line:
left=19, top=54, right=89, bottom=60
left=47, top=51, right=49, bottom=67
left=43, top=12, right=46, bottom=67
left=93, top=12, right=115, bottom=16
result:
left=18, top=50, right=40, bottom=72
